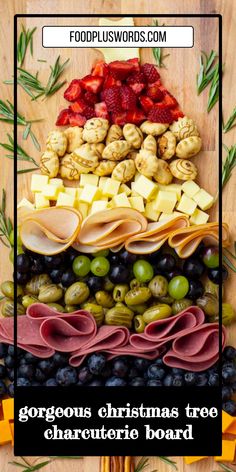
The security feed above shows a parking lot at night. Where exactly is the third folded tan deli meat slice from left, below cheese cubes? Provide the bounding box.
[125,216,189,254]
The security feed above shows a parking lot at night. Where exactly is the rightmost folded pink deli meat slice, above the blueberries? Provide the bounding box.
[163,323,226,372]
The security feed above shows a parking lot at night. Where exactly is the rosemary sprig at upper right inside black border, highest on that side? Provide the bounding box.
[197,50,218,95]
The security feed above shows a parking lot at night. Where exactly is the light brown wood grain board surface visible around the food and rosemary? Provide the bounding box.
[0,0,236,472]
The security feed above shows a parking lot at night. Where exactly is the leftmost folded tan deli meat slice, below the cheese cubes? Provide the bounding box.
[20,207,81,255]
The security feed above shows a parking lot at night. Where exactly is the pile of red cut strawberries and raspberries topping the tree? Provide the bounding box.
[56,58,184,126]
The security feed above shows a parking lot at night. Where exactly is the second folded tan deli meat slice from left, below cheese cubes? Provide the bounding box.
[78,208,147,249]
